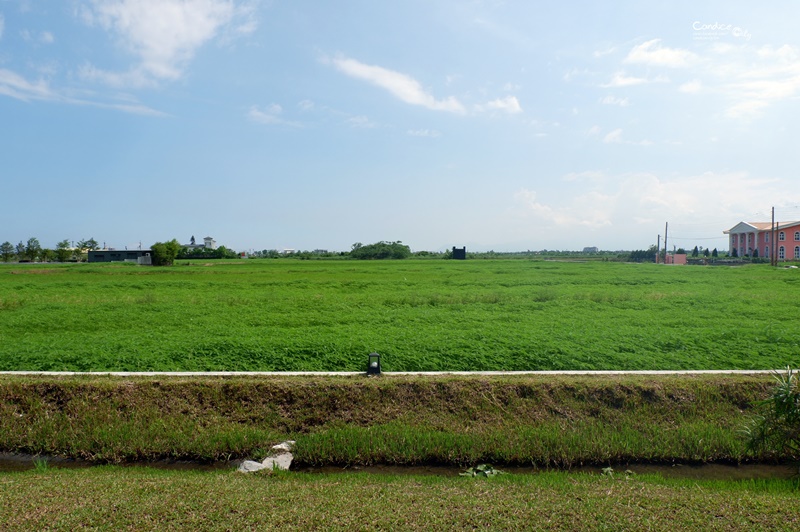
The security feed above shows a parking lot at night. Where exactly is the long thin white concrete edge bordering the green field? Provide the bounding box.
[0,368,785,377]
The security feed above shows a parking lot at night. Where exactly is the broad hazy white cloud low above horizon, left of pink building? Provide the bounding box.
[510,171,784,249]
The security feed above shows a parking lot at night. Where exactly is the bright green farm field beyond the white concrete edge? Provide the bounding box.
[0,259,800,371]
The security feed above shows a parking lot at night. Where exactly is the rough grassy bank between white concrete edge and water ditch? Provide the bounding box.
[0,375,787,466]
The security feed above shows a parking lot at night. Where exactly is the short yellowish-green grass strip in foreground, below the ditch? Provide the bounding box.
[0,467,800,531]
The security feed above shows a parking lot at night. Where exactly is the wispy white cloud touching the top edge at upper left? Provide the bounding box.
[81,0,245,87]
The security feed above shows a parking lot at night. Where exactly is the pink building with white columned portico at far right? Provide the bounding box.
[723,222,800,260]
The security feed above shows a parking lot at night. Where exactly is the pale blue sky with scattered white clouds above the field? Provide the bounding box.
[0,0,800,251]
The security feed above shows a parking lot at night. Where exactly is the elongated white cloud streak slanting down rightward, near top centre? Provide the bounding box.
[330,57,465,114]
